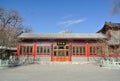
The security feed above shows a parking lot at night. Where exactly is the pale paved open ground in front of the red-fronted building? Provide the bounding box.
[0,64,120,81]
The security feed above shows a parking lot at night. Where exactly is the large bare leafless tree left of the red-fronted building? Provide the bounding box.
[0,8,31,54]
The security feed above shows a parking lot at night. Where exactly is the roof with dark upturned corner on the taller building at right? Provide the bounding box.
[98,22,120,45]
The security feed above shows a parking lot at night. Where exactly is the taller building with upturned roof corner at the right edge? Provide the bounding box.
[98,22,120,57]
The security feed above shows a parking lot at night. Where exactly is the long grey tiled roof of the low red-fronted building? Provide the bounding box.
[18,33,107,39]
